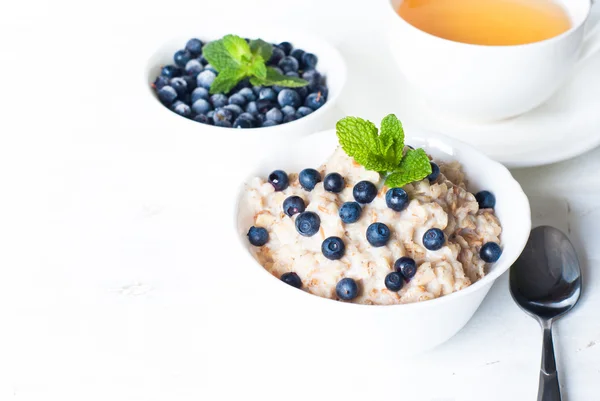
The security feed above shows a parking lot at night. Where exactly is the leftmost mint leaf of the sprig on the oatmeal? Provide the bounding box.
[335,117,396,172]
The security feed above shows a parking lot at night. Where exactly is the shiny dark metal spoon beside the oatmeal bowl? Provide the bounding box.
[510,226,581,401]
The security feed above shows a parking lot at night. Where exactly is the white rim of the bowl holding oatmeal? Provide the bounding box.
[233,129,531,310]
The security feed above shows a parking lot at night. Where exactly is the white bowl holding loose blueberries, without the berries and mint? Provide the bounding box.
[143,27,346,161]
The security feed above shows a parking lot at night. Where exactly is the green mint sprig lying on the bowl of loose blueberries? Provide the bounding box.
[202,35,308,94]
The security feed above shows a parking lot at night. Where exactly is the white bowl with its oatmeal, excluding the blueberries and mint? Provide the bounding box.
[236,125,531,355]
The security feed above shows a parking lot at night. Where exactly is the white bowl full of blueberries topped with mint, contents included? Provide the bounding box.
[145,29,346,141]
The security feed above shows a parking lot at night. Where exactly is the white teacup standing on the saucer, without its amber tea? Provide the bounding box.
[386,0,600,121]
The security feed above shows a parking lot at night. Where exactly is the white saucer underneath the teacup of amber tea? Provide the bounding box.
[340,18,600,167]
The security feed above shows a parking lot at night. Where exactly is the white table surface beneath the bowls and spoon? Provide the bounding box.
[0,0,600,401]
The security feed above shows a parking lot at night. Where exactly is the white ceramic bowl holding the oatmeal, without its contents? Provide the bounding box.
[233,127,531,356]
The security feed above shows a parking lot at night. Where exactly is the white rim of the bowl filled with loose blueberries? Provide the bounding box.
[142,28,348,134]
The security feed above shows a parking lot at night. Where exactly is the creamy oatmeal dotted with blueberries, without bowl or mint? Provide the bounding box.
[243,148,501,305]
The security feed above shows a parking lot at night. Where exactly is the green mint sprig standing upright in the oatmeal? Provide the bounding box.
[336,114,431,187]
